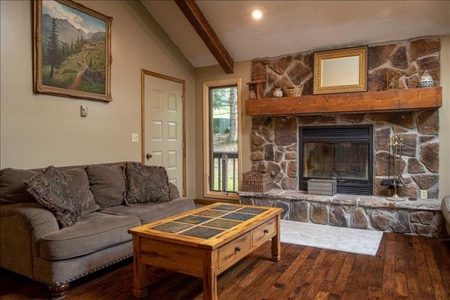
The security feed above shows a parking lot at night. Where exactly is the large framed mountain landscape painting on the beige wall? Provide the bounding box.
[33,0,112,101]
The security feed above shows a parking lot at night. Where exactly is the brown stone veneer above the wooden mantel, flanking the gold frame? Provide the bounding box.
[251,38,441,97]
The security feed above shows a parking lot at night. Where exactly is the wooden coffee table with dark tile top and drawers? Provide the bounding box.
[129,203,282,299]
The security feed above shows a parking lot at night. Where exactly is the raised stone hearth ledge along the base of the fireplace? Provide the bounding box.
[240,189,447,237]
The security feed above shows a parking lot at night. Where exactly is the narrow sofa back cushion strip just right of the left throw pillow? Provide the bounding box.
[60,168,100,215]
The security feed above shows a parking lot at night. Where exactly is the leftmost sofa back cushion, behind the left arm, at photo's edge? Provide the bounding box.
[0,168,37,204]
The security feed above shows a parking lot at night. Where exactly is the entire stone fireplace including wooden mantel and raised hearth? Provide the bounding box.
[240,38,446,237]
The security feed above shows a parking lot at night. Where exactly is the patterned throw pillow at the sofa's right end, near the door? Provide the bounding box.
[125,162,171,205]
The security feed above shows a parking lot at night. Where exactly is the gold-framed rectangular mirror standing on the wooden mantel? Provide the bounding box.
[313,46,368,95]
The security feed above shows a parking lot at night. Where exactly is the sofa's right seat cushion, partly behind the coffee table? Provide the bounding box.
[102,198,195,224]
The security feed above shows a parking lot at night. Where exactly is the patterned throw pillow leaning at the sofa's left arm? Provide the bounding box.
[25,166,82,228]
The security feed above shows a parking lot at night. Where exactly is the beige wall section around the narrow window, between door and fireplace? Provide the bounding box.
[195,61,252,198]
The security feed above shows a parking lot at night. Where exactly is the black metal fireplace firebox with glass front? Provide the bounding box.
[298,125,374,195]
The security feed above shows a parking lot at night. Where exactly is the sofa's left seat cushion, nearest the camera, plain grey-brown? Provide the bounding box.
[40,211,141,260]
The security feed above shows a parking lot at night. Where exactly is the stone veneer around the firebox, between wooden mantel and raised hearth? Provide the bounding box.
[250,111,439,198]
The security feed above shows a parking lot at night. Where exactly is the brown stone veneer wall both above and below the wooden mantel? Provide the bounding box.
[250,38,441,198]
